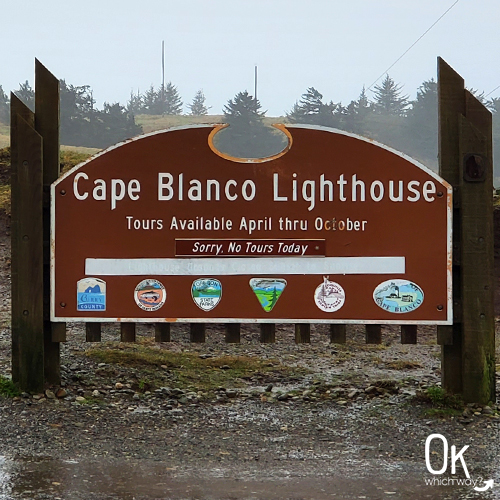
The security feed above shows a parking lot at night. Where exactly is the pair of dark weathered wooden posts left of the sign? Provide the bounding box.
[11,60,66,392]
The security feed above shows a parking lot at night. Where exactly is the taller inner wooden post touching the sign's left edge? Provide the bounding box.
[35,59,66,384]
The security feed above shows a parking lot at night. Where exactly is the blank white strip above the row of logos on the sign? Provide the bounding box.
[85,257,405,276]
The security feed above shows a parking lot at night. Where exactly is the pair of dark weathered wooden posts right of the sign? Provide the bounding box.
[438,58,495,404]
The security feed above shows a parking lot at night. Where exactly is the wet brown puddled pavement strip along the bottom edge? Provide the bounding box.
[0,458,500,500]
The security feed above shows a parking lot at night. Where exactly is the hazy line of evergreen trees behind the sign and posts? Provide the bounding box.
[0,75,500,178]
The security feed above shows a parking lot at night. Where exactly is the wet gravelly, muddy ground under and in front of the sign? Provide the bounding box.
[0,212,500,500]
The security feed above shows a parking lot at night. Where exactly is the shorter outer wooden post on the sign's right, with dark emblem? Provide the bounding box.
[459,90,496,404]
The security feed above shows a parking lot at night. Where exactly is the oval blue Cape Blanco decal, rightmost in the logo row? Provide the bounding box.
[373,280,424,314]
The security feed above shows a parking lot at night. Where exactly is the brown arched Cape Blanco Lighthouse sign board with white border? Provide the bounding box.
[51,126,452,324]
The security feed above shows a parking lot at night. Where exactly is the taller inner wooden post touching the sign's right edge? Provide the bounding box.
[438,58,465,394]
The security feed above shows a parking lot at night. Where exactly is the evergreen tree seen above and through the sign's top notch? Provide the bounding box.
[214,90,287,158]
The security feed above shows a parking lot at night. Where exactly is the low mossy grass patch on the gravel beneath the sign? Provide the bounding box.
[85,344,306,392]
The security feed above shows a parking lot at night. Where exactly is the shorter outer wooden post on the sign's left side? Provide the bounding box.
[11,113,44,392]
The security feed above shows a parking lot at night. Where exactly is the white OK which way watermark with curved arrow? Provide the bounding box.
[425,434,494,491]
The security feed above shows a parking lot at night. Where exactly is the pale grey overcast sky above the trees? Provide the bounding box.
[0,0,500,115]
